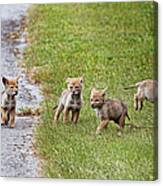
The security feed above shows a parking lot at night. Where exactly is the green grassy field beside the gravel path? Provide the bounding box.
[25,2,157,180]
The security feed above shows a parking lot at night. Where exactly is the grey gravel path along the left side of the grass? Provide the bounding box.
[0,4,43,177]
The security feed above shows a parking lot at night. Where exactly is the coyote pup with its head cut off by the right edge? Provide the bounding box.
[125,79,158,111]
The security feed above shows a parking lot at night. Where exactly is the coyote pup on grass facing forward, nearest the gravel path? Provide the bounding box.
[54,77,83,124]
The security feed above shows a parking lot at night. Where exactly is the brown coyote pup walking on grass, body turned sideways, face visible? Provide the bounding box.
[90,88,130,134]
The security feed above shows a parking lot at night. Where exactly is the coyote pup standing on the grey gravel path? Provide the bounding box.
[1,77,19,128]
